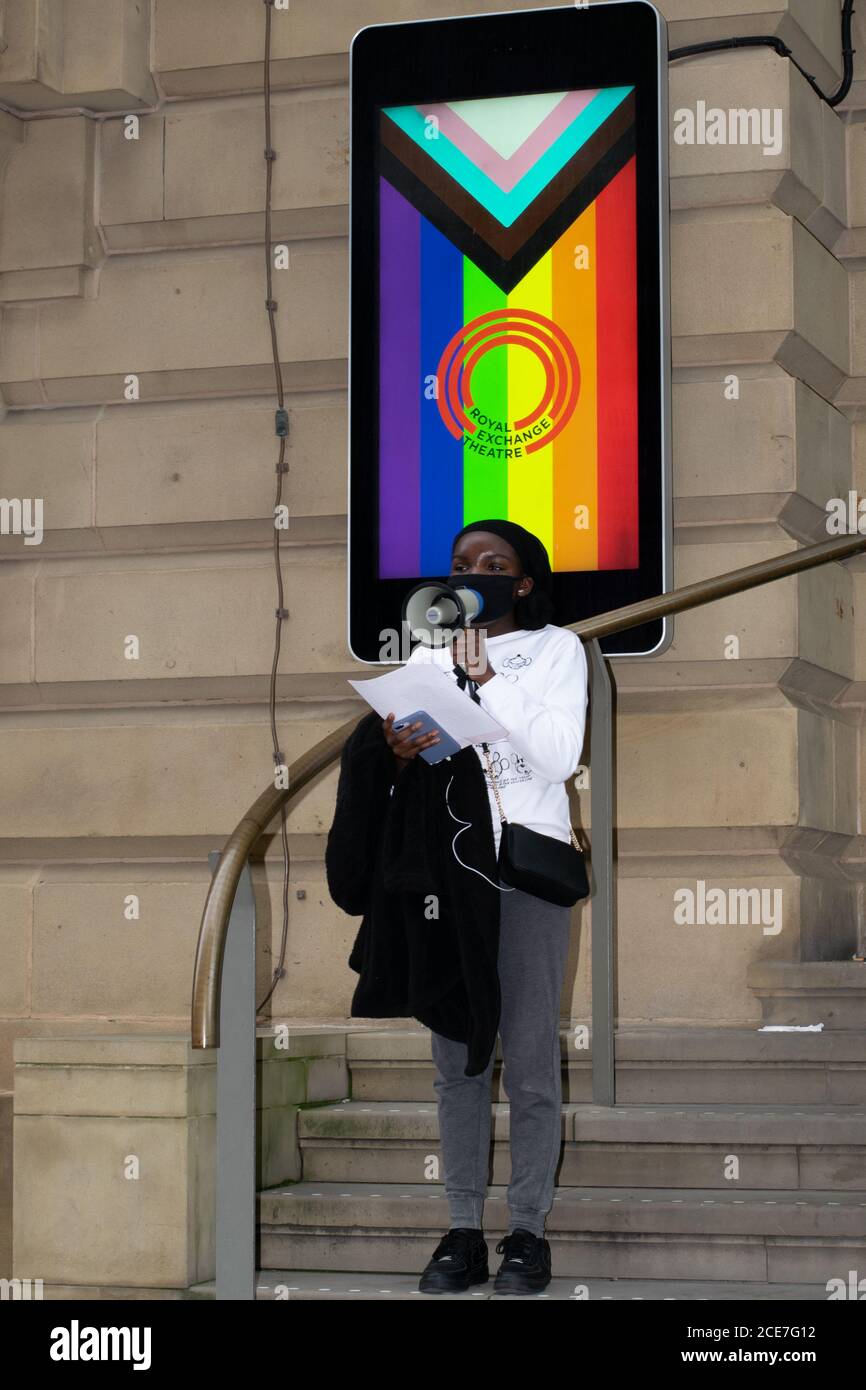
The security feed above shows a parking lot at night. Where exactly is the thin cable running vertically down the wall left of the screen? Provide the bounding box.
[256,0,289,1015]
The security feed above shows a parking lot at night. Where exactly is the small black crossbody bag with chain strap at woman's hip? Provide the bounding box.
[481,744,589,908]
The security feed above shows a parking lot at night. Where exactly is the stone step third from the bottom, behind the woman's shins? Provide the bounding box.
[297,1101,866,1191]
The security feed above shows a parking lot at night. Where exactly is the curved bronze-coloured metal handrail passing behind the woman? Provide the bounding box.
[192,535,866,1048]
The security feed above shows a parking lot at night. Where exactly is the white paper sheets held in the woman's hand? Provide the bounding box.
[349,664,509,748]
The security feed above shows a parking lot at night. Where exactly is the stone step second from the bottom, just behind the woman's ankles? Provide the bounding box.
[259,1182,866,1284]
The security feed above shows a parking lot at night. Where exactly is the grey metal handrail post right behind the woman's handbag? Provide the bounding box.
[587,638,616,1105]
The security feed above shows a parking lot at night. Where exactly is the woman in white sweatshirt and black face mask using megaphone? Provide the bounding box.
[382,518,587,1293]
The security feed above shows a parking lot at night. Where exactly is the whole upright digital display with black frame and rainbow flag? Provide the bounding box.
[348,0,673,663]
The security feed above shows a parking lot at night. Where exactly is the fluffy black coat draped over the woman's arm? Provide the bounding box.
[325,710,500,1076]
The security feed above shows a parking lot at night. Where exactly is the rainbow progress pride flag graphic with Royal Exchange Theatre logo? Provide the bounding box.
[379,86,638,578]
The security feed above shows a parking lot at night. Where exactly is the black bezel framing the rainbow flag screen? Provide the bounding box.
[348,0,670,663]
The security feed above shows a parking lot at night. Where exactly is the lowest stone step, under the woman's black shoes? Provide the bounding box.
[241,1273,827,1302]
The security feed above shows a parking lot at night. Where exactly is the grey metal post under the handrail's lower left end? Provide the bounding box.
[209,851,256,1302]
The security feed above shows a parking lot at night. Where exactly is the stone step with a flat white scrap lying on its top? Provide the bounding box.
[346,1023,866,1105]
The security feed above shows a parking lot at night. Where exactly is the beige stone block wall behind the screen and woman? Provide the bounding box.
[0,0,866,1088]
